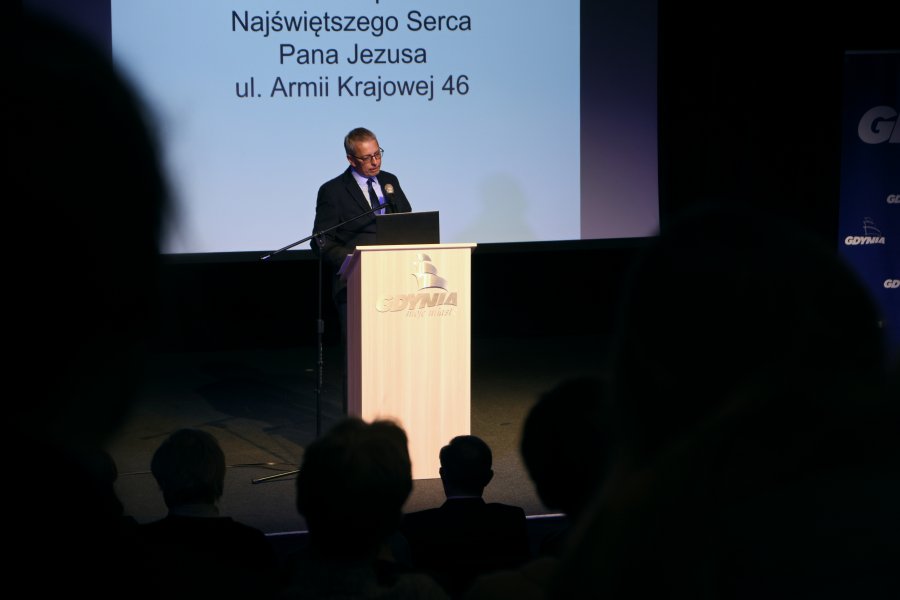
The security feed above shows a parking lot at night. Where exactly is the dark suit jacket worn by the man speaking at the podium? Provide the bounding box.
[309,167,412,298]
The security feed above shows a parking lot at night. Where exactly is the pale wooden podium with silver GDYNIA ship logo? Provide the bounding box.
[341,243,476,479]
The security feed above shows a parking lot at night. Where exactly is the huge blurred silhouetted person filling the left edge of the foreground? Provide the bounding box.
[14,9,168,598]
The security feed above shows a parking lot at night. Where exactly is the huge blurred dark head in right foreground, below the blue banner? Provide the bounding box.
[613,206,885,466]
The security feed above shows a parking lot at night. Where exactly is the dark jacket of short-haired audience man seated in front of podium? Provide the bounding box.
[400,498,531,596]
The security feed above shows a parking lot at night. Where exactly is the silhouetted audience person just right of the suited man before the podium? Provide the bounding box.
[464,376,614,600]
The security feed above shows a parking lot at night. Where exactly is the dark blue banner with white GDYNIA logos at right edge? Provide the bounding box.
[838,51,900,360]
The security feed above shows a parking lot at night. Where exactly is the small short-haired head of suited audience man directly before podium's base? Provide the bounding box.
[440,435,494,496]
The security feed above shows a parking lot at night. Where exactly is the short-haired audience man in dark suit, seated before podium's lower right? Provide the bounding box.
[400,435,531,596]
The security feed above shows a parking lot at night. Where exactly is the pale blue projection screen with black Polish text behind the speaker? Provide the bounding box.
[111,0,581,253]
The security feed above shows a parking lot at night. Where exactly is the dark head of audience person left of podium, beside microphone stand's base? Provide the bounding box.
[150,429,225,508]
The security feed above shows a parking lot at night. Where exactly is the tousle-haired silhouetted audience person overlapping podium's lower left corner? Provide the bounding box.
[281,417,448,600]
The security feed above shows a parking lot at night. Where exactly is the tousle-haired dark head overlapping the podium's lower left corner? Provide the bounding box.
[297,417,412,559]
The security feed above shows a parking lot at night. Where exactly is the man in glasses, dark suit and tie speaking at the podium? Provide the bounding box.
[310,127,412,414]
